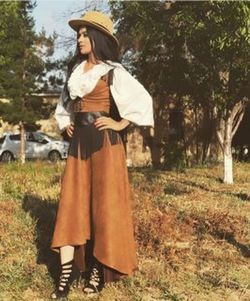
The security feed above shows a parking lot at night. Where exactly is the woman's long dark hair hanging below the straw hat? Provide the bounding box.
[67,26,120,78]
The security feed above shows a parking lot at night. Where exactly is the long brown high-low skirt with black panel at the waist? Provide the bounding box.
[51,112,137,282]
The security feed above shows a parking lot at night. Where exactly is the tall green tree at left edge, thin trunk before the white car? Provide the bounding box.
[0,1,55,163]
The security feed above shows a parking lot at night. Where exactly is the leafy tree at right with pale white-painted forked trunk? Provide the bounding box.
[176,1,250,183]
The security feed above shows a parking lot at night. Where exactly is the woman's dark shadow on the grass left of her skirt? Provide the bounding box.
[22,194,60,282]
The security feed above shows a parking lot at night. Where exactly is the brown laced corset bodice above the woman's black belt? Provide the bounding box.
[73,76,110,113]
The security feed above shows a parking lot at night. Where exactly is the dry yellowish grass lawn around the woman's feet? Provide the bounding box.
[0,161,250,301]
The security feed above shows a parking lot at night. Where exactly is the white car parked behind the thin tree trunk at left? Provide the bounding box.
[0,132,69,162]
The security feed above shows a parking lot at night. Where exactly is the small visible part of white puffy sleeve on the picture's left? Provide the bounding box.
[54,95,74,132]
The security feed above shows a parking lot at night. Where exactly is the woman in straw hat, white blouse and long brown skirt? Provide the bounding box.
[51,11,154,298]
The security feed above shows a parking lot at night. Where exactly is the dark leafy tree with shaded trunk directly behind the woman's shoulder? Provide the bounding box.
[110,1,185,167]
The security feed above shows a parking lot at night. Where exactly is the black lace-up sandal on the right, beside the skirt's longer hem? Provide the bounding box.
[83,262,104,295]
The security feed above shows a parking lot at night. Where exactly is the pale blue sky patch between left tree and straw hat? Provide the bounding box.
[32,0,107,58]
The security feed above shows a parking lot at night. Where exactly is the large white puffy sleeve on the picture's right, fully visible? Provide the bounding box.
[110,65,154,126]
